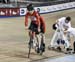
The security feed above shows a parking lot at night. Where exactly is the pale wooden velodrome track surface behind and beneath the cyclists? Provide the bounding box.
[0,9,75,62]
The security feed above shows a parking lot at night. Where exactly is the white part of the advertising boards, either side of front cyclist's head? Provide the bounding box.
[20,2,75,16]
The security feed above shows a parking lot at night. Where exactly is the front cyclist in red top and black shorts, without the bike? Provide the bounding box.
[25,4,40,46]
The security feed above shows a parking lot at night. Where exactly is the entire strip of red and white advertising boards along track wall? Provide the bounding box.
[0,2,75,16]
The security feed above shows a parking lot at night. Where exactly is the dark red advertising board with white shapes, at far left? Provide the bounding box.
[0,8,20,16]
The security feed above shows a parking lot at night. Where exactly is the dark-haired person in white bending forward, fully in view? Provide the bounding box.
[50,16,71,51]
